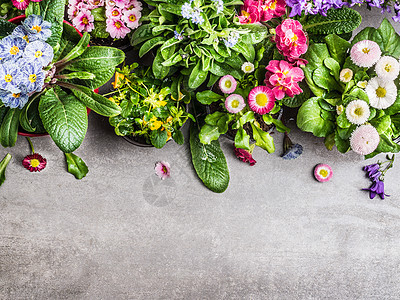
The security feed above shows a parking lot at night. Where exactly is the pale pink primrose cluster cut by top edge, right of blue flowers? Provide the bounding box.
[68,0,142,39]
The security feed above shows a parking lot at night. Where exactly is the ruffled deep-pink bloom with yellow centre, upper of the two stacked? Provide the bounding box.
[275,19,308,61]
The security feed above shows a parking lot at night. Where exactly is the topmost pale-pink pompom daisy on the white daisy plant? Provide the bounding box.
[350,40,382,68]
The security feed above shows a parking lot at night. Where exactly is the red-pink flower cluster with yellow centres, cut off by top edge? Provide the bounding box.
[239,0,286,24]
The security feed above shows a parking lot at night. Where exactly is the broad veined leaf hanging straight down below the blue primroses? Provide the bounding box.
[39,87,88,153]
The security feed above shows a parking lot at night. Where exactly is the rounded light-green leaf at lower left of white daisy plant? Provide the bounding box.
[297,97,335,137]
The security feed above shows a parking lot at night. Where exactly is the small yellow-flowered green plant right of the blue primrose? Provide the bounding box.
[110,63,192,148]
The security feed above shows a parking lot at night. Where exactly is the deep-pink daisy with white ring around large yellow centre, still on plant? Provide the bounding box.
[249,85,276,115]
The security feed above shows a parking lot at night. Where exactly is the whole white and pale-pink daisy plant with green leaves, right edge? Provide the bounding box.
[297,19,400,158]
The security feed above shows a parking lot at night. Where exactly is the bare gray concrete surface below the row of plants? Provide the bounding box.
[0,6,400,299]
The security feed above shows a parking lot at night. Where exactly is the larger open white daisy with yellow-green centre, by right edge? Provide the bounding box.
[365,77,397,109]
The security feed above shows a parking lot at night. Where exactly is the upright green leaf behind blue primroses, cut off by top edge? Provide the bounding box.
[25,0,65,49]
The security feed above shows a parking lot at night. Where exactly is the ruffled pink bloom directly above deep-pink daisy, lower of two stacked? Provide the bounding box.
[264,60,304,100]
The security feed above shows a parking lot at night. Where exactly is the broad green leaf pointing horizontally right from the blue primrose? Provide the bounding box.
[66,46,125,73]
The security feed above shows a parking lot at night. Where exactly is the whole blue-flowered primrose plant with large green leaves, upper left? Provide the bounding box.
[0,0,125,153]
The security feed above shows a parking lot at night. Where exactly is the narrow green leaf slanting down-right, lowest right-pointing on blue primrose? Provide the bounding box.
[65,85,121,117]
